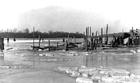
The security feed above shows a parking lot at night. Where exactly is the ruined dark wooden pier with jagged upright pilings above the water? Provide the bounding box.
[32,24,140,51]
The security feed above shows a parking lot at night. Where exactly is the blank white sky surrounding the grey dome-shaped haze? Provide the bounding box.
[0,0,140,30]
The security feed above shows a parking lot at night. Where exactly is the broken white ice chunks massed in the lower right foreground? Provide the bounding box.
[58,67,140,83]
